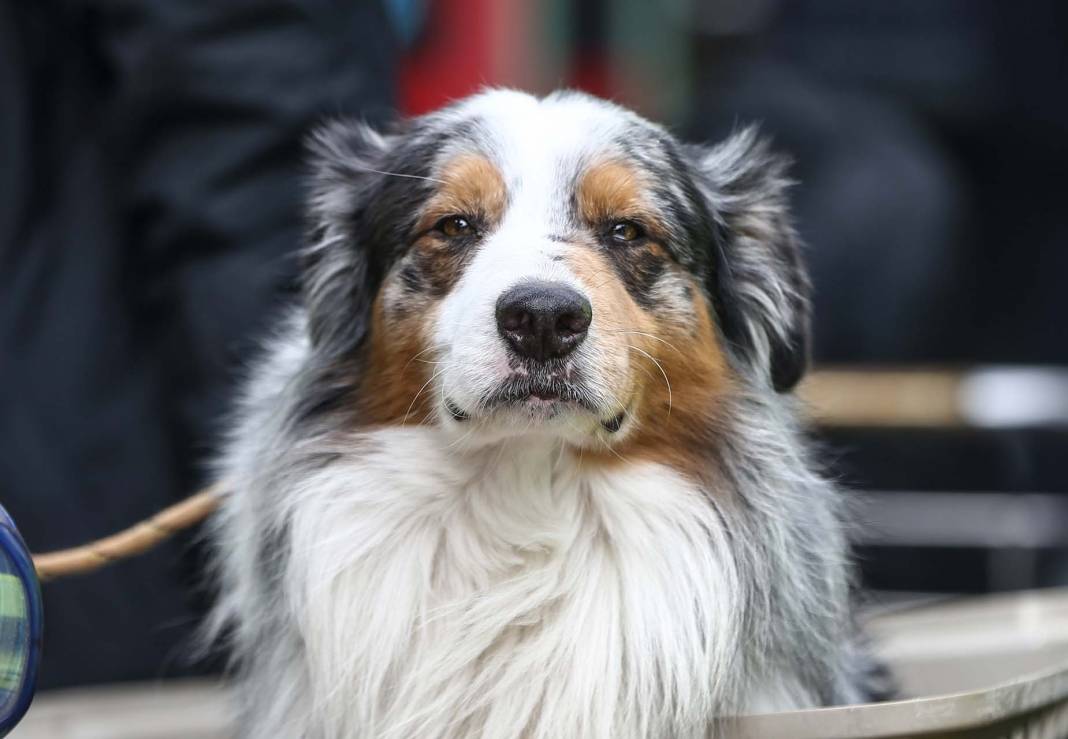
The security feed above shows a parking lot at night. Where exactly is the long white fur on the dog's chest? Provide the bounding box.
[286,429,760,738]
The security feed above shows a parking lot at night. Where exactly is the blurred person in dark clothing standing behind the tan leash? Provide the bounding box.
[0,0,395,688]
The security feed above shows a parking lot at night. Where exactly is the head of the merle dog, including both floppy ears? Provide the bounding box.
[304,91,808,449]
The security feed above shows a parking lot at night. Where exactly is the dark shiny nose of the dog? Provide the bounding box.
[497,282,594,362]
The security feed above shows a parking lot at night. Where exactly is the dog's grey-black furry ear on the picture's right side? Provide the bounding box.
[692,128,811,392]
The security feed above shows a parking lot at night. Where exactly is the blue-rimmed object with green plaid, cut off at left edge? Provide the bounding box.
[0,506,43,737]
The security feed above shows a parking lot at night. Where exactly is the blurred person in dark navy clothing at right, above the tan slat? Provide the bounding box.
[688,0,1068,365]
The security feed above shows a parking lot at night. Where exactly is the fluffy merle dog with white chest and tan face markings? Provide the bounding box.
[211,90,869,739]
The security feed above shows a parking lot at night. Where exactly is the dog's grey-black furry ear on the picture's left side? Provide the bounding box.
[301,121,394,357]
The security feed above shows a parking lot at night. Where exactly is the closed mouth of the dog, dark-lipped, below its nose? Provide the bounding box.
[444,375,627,434]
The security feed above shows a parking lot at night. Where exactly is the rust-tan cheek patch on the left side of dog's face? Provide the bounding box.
[355,293,435,426]
